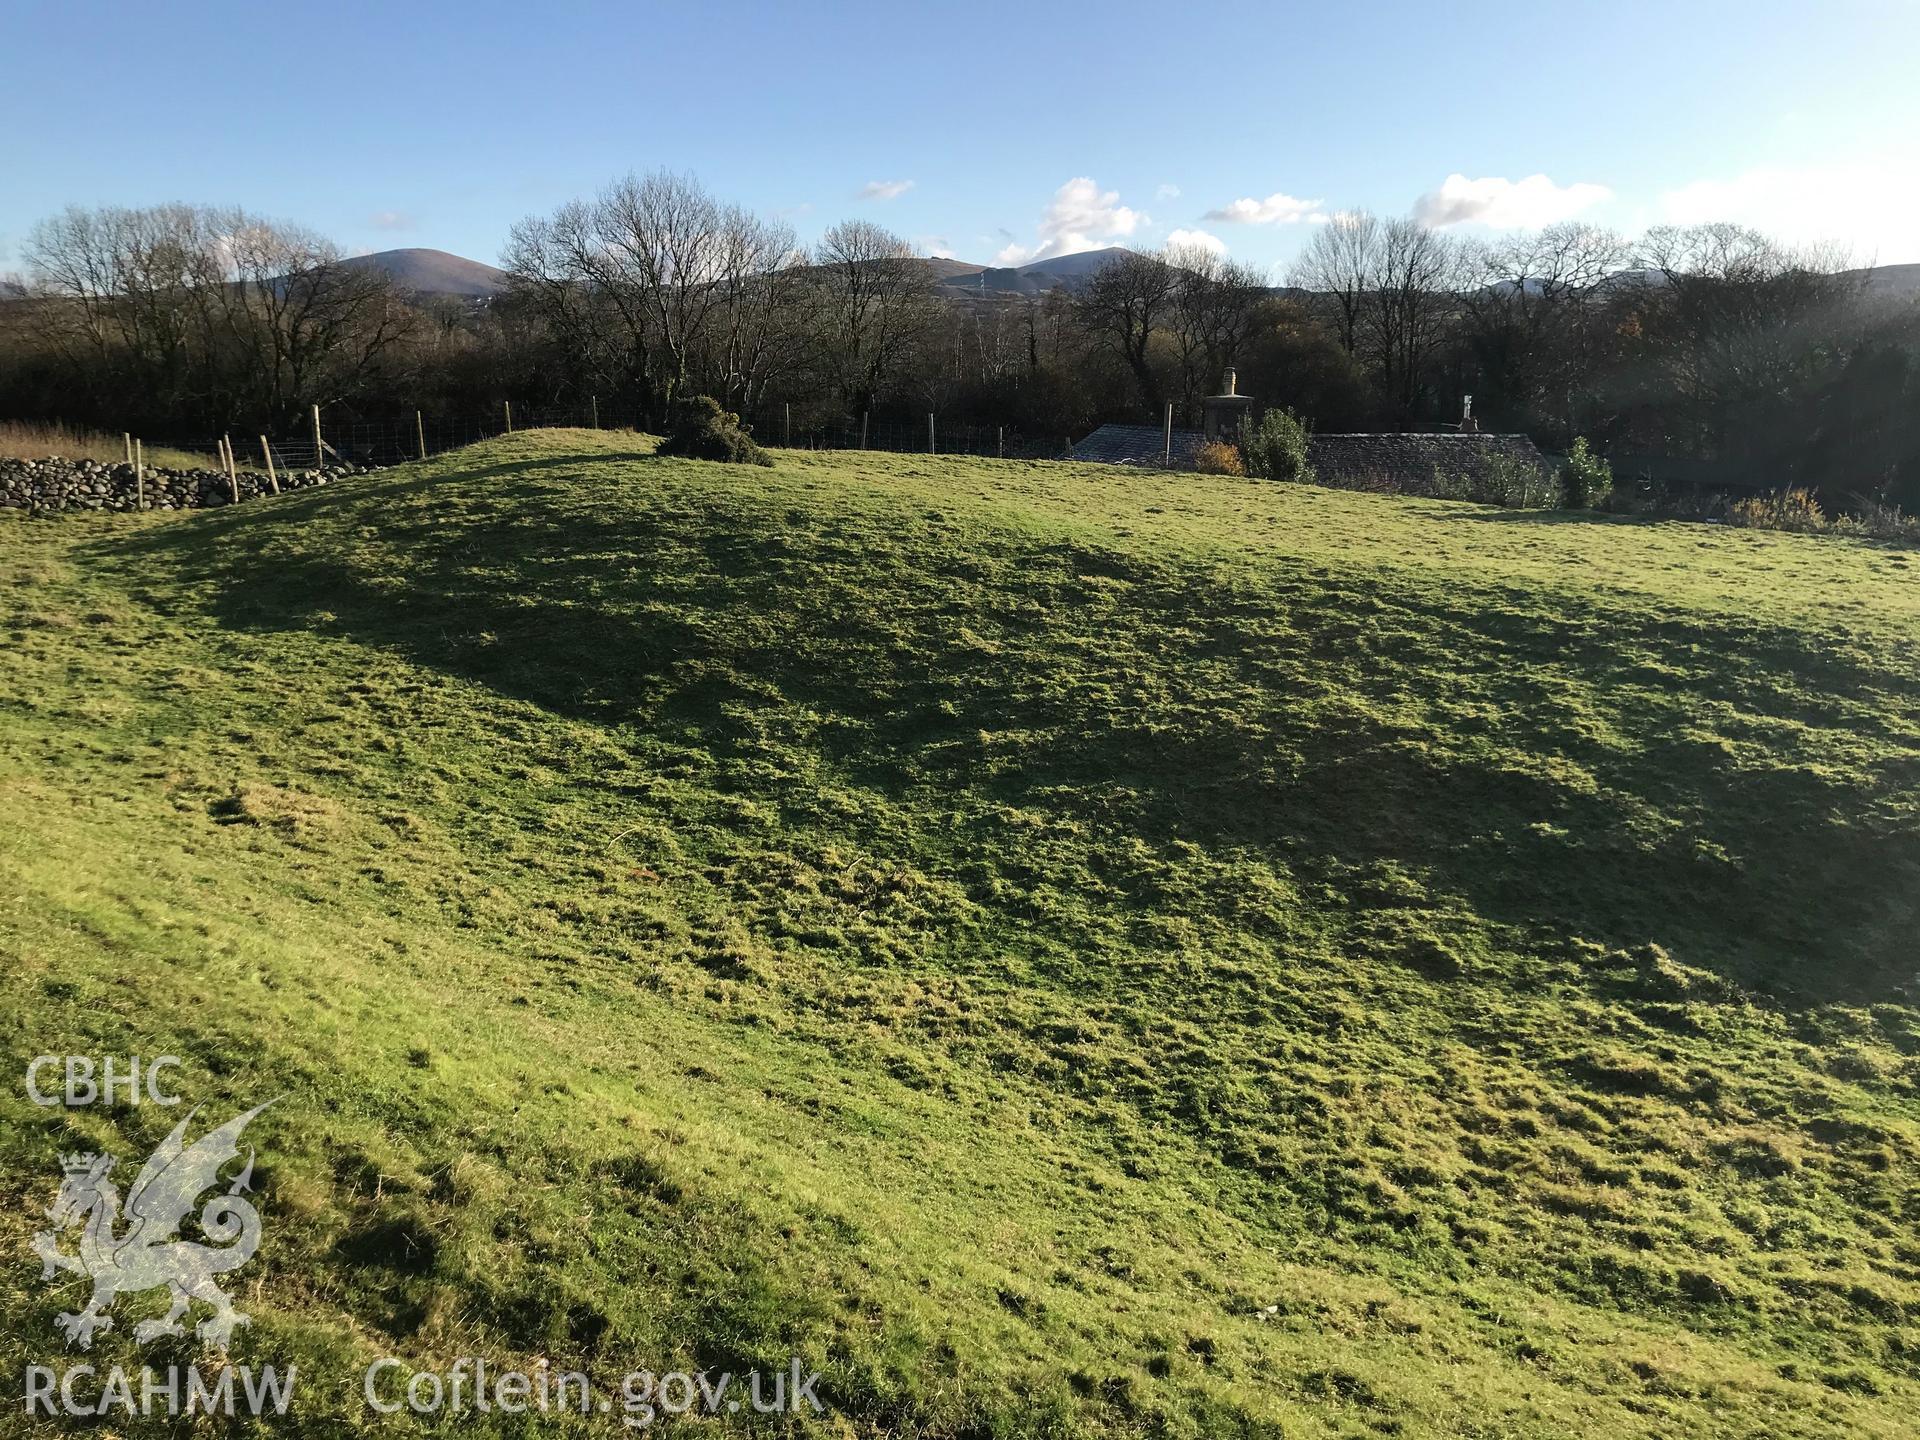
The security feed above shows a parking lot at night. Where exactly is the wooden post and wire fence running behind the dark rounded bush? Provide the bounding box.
[140,399,1071,470]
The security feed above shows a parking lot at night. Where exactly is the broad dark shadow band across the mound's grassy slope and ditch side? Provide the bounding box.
[100,455,1920,1000]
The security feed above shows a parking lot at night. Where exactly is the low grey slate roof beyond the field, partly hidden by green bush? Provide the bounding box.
[1073,424,1546,490]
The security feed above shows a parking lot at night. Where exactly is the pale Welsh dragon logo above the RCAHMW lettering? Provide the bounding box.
[33,1100,273,1350]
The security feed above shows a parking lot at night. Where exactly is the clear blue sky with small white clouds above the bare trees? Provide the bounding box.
[0,0,1920,271]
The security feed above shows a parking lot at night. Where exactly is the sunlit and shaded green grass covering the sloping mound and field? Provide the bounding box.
[0,432,1920,1436]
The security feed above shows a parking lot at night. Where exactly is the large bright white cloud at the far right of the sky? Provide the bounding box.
[1657,154,1920,265]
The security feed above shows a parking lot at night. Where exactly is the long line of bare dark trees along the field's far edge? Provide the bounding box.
[0,173,1920,505]
